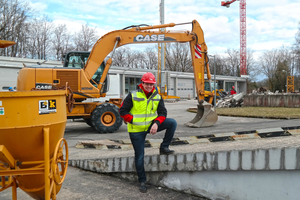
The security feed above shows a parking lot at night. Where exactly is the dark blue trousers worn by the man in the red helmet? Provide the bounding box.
[129,118,177,183]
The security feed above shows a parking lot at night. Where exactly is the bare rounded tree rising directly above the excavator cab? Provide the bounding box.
[74,24,99,51]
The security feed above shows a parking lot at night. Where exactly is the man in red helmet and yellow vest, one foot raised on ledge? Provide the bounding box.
[120,72,177,193]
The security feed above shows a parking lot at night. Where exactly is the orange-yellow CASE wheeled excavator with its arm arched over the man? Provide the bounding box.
[17,20,218,133]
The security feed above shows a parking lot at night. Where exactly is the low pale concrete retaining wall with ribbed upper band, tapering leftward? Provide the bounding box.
[69,147,300,200]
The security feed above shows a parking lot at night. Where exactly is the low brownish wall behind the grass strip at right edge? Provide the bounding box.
[244,93,300,108]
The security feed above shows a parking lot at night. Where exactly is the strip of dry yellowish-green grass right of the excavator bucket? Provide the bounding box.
[216,107,300,119]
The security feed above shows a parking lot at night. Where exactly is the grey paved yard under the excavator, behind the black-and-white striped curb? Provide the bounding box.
[65,100,300,146]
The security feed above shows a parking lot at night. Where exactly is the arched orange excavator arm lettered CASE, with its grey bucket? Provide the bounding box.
[84,20,217,127]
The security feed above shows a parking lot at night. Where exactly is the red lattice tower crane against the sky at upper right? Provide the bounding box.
[221,0,247,76]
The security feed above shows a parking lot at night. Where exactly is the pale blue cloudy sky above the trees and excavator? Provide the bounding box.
[25,0,300,55]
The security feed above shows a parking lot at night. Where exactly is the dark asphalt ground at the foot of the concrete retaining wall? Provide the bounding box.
[0,167,205,200]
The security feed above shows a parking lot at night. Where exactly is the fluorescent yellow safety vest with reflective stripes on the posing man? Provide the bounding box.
[127,90,161,133]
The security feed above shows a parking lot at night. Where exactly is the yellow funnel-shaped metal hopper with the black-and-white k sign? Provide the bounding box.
[0,90,67,199]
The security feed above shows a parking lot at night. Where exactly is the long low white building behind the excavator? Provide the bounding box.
[0,56,247,101]
